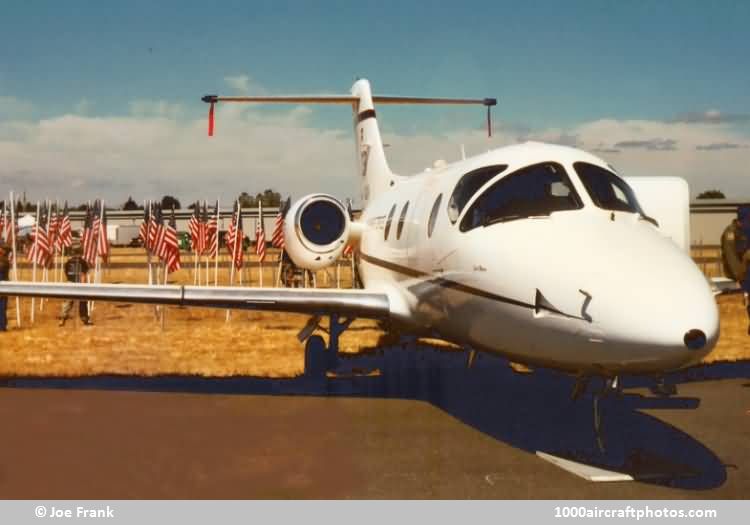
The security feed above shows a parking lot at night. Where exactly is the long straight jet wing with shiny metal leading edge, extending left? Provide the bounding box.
[0,281,390,319]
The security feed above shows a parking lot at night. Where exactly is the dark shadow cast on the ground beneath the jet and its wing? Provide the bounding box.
[5,343,750,489]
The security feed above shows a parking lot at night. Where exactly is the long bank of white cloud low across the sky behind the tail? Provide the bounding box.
[0,100,750,207]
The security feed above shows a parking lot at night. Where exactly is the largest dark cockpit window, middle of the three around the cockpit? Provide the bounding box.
[461,162,583,231]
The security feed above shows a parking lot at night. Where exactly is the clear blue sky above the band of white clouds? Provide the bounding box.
[0,1,750,202]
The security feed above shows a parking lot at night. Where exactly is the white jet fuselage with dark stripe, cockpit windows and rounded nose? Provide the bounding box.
[359,143,719,375]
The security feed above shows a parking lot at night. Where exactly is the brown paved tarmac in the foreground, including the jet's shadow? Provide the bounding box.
[0,346,750,499]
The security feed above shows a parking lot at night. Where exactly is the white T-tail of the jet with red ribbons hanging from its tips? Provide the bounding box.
[202,79,497,205]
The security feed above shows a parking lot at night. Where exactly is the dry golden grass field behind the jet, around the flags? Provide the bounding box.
[0,249,750,377]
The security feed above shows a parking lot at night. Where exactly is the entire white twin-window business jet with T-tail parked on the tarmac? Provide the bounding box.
[0,80,719,383]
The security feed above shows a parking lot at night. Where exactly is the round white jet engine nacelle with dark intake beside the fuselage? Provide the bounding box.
[284,193,351,270]
